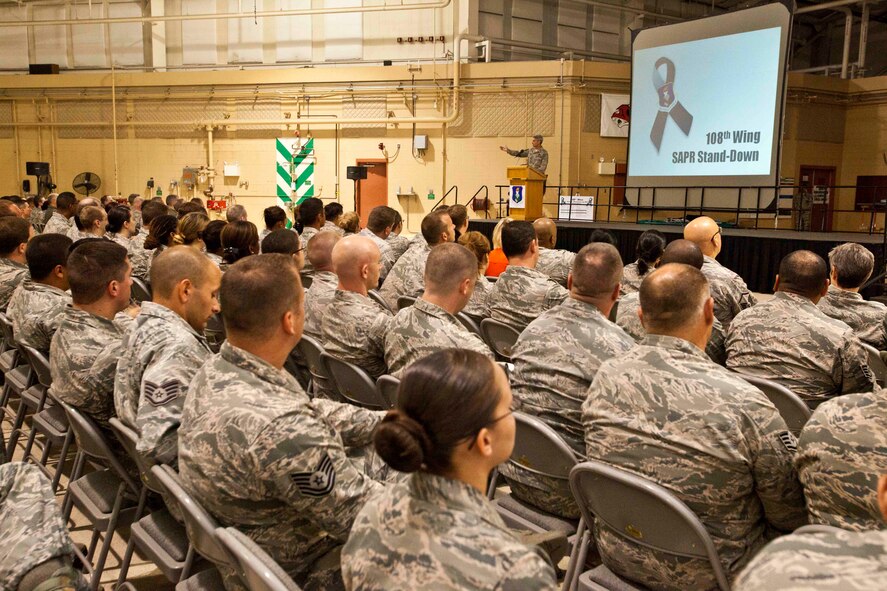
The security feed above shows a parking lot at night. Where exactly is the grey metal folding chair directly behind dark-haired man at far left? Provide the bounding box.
[59,402,144,589]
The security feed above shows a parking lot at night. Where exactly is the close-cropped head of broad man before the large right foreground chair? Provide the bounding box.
[640,263,709,335]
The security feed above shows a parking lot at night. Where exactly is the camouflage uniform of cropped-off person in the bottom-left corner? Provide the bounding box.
[0,462,88,591]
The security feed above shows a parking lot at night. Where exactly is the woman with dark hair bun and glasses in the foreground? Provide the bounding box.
[342,349,556,591]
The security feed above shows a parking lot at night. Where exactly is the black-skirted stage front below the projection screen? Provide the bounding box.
[468,219,884,298]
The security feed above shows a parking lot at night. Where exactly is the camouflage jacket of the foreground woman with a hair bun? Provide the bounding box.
[342,472,557,591]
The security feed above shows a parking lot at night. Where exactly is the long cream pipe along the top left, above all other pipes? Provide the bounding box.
[0,0,452,28]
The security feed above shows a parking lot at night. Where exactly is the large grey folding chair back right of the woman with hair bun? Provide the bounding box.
[570,461,730,591]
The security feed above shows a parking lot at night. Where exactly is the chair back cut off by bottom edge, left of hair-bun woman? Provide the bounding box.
[216,527,300,591]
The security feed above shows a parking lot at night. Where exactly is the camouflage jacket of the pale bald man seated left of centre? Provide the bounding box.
[321,289,392,379]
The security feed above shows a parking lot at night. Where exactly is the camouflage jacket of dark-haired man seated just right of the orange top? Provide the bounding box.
[488,265,570,331]
